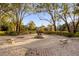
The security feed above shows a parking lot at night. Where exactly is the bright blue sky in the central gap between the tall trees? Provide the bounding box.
[23,14,50,27]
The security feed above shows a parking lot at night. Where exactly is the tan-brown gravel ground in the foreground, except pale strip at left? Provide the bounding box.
[0,35,79,56]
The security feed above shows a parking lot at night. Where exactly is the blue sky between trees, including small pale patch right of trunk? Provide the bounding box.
[23,13,64,27]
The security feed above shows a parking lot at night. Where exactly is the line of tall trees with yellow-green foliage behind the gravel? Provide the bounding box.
[0,3,79,34]
